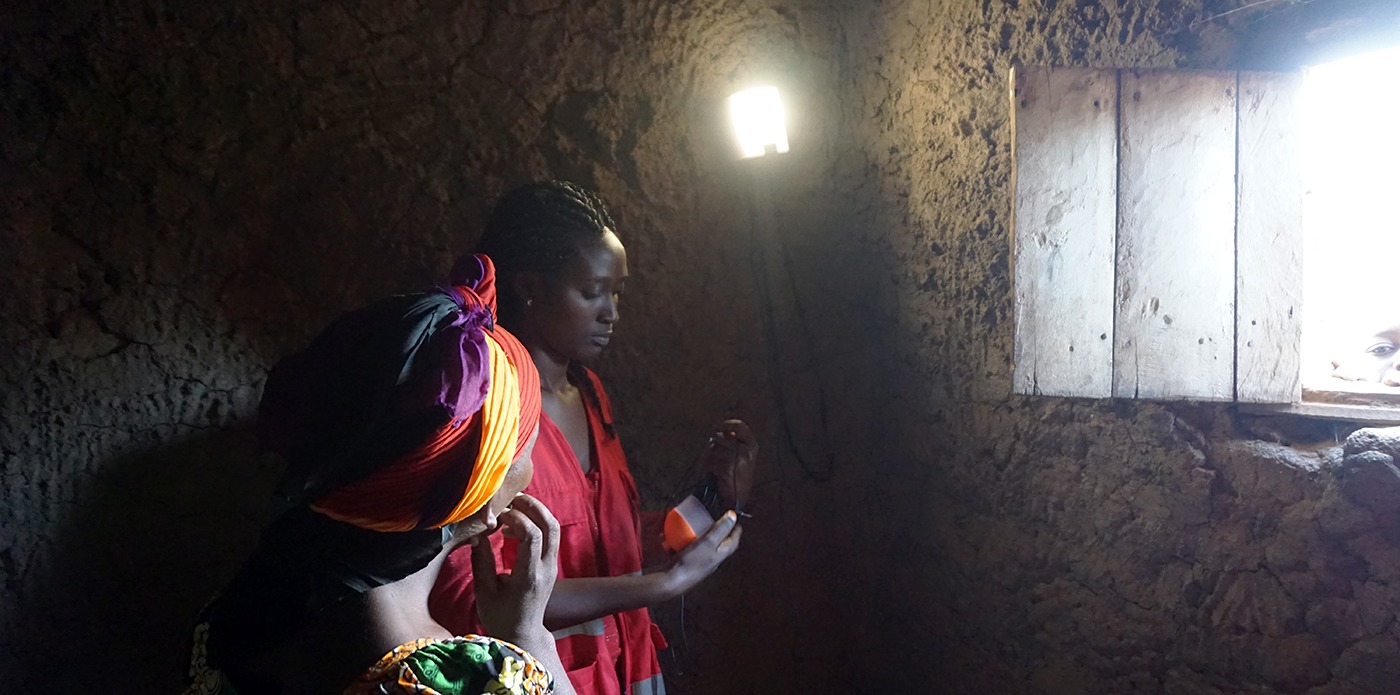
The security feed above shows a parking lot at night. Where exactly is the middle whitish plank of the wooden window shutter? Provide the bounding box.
[1113,70,1235,401]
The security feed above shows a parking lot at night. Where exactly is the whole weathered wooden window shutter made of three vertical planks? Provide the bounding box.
[1012,67,1302,402]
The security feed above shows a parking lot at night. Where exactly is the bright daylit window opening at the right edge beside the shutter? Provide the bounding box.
[1301,49,1400,402]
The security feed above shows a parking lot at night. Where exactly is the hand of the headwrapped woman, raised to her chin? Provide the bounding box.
[472,493,559,646]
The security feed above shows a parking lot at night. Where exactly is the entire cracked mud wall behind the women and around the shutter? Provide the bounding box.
[8,0,1400,694]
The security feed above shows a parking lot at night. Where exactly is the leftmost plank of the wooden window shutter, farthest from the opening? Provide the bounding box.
[1011,67,1117,398]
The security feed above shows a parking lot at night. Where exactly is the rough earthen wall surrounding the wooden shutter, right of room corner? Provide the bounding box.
[828,0,1400,694]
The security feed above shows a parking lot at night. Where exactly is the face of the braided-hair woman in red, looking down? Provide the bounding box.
[521,230,627,362]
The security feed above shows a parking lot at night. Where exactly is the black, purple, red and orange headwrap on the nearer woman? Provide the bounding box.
[259,256,540,531]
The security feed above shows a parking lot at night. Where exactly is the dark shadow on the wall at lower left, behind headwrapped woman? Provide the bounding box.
[14,425,280,692]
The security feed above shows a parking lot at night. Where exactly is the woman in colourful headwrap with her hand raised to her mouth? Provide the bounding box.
[186,256,573,695]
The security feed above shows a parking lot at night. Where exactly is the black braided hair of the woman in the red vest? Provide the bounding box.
[476,181,617,436]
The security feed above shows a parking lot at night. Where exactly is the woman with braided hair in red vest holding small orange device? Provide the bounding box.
[430,181,757,695]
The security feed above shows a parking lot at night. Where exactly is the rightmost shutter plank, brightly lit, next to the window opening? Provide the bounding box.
[1235,73,1303,404]
